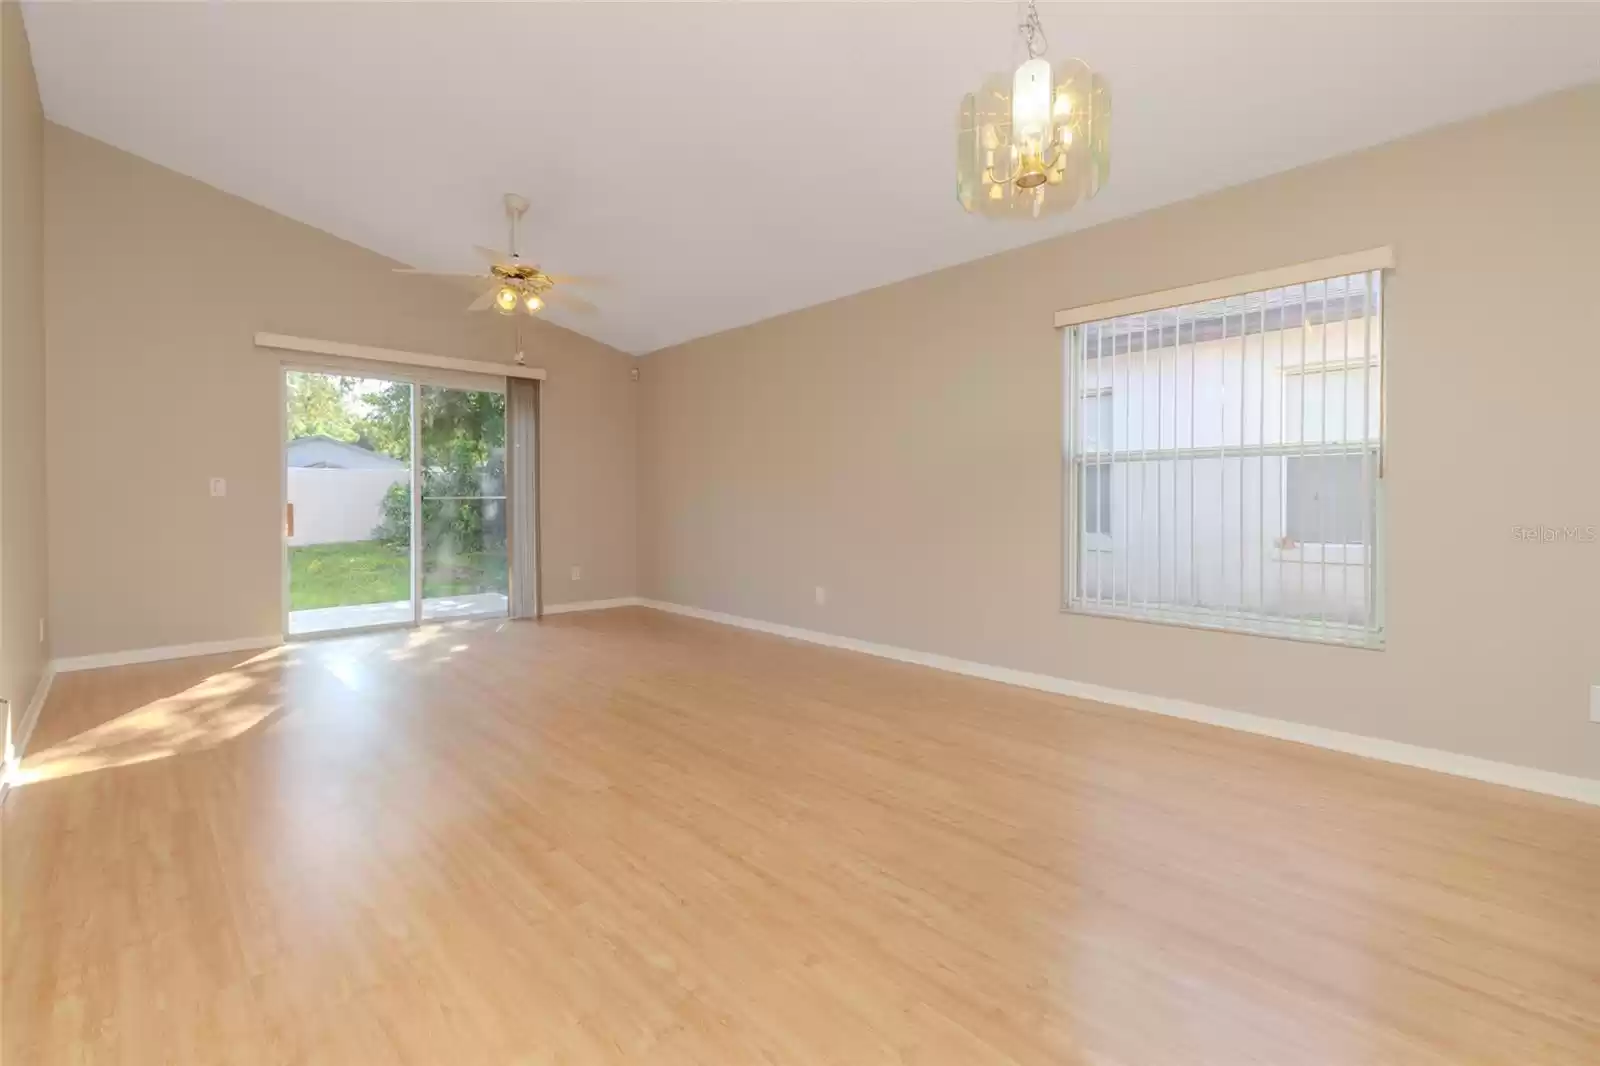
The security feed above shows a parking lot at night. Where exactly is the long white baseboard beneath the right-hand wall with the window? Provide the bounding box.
[640,600,1600,807]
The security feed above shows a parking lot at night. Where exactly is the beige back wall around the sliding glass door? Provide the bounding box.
[45,125,637,656]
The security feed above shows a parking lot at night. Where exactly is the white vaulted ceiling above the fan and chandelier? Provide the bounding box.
[26,3,1600,352]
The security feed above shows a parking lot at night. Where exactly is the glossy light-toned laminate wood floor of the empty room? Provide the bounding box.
[0,610,1600,1066]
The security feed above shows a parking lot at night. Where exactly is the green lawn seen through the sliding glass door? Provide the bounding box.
[290,541,506,611]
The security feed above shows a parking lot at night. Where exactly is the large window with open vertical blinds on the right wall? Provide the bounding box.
[1064,262,1384,645]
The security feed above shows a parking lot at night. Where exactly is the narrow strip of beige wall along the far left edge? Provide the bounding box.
[0,3,48,720]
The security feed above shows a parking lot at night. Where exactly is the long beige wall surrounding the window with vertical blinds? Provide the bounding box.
[638,86,1600,776]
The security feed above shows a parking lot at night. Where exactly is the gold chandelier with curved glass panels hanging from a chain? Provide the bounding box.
[955,0,1110,218]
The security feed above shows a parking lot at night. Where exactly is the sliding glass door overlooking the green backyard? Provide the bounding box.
[283,370,510,635]
